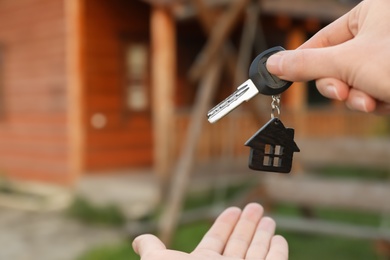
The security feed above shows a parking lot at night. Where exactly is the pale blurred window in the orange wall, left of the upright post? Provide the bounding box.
[125,43,149,111]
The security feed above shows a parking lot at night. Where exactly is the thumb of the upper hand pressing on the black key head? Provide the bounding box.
[267,46,348,81]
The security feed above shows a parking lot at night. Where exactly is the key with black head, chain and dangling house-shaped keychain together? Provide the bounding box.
[207,47,299,173]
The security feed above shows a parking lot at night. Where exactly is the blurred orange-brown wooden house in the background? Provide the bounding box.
[0,0,380,184]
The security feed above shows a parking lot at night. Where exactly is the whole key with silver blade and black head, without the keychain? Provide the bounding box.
[207,46,292,123]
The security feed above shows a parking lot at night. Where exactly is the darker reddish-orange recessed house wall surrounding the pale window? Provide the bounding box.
[84,0,153,172]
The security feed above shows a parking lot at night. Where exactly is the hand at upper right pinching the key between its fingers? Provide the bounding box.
[267,0,390,112]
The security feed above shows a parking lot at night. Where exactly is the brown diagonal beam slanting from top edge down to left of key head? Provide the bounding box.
[189,0,249,81]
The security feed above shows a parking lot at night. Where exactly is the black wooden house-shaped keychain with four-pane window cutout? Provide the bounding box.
[245,117,300,173]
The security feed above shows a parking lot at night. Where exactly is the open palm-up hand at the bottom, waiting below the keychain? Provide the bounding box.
[133,203,288,260]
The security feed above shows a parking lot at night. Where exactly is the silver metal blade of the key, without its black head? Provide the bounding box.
[207,79,259,123]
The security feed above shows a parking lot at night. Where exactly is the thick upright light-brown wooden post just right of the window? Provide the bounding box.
[150,5,176,194]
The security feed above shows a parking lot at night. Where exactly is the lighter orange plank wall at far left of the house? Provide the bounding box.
[0,0,72,183]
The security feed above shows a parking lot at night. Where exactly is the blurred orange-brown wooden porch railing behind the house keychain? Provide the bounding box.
[174,106,390,162]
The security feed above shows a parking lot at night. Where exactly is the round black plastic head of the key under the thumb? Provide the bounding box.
[249,46,292,96]
